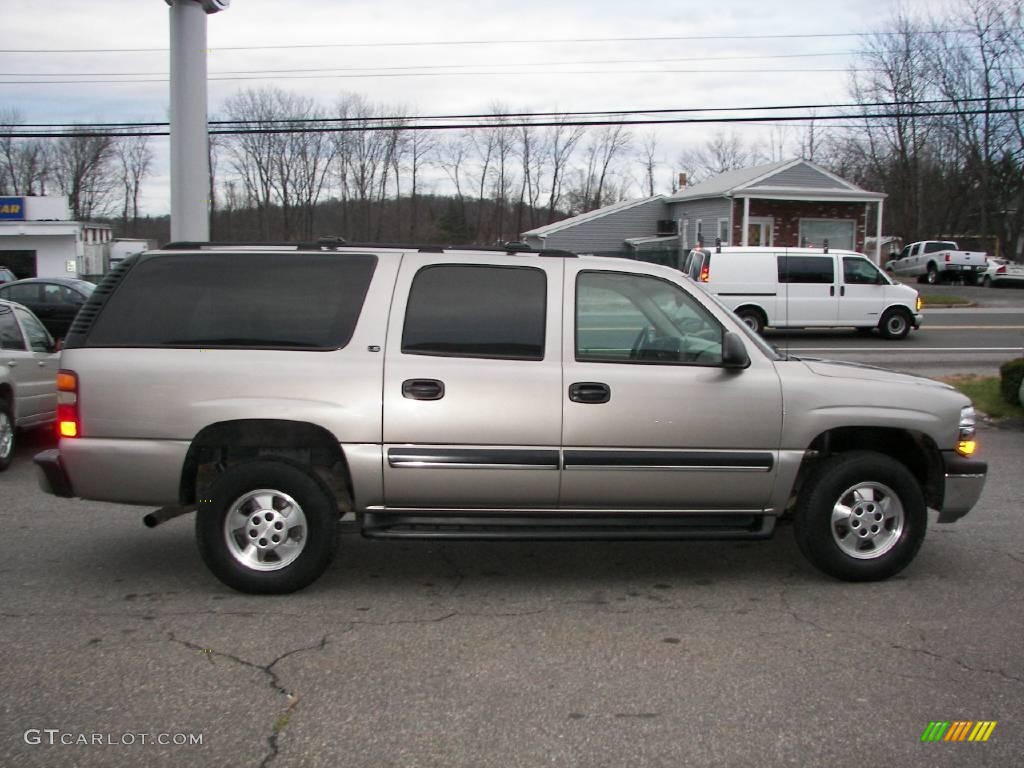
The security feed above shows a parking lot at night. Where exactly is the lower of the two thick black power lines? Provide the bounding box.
[4,108,1024,138]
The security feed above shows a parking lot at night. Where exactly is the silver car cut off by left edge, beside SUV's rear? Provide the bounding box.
[0,300,57,471]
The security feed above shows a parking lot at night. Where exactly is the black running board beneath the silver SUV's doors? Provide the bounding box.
[362,510,775,541]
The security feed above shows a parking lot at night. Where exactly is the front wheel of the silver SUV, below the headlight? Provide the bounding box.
[794,451,928,582]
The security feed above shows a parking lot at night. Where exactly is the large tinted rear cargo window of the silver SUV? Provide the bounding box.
[86,252,377,349]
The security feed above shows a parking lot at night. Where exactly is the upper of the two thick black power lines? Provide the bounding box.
[11,96,1020,131]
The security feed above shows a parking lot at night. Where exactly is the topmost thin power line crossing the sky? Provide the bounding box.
[0,29,970,53]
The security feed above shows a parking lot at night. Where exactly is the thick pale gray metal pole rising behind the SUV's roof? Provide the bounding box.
[166,0,231,241]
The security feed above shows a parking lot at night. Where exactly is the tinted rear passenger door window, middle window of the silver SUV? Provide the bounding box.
[401,264,548,360]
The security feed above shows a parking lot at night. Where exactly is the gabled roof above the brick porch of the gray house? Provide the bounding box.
[666,158,886,203]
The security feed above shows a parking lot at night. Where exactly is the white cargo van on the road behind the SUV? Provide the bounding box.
[681,247,922,339]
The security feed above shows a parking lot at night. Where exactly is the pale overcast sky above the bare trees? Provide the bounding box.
[0,0,948,213]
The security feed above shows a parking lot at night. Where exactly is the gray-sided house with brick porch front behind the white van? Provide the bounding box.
[522,159,886,263]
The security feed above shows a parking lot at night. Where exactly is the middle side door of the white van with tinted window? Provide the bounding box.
[772,253,839,328]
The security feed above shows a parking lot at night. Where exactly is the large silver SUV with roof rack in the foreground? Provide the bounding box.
[36,244,986,593]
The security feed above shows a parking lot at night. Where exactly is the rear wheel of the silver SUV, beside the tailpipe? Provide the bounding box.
[196,460,338,595]
